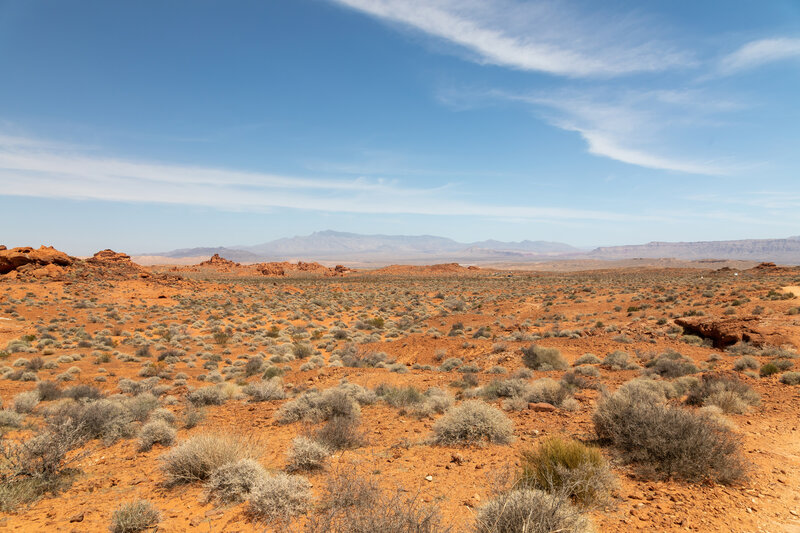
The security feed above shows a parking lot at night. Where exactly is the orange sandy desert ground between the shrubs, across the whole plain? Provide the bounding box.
[0,262,800,532]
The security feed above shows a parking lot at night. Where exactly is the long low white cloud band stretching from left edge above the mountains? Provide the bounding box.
[0,134,636,222]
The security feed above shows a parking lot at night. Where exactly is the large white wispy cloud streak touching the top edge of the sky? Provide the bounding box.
[333,0,694,77]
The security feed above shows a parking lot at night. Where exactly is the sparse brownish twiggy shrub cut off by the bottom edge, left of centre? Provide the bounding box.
[305,469,450,533]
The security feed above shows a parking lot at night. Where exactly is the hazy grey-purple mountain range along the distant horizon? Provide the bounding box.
[141,230,800,264]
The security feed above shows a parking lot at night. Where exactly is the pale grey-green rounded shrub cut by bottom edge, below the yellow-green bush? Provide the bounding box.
[475,489,593,533]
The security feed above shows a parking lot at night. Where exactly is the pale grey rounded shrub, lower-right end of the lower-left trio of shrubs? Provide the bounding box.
[247,473,311,522]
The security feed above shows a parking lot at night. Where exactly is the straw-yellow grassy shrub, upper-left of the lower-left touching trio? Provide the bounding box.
[160,434,255,484]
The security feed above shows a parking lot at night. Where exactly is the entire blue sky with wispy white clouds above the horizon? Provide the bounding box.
[0,0,800,254]
